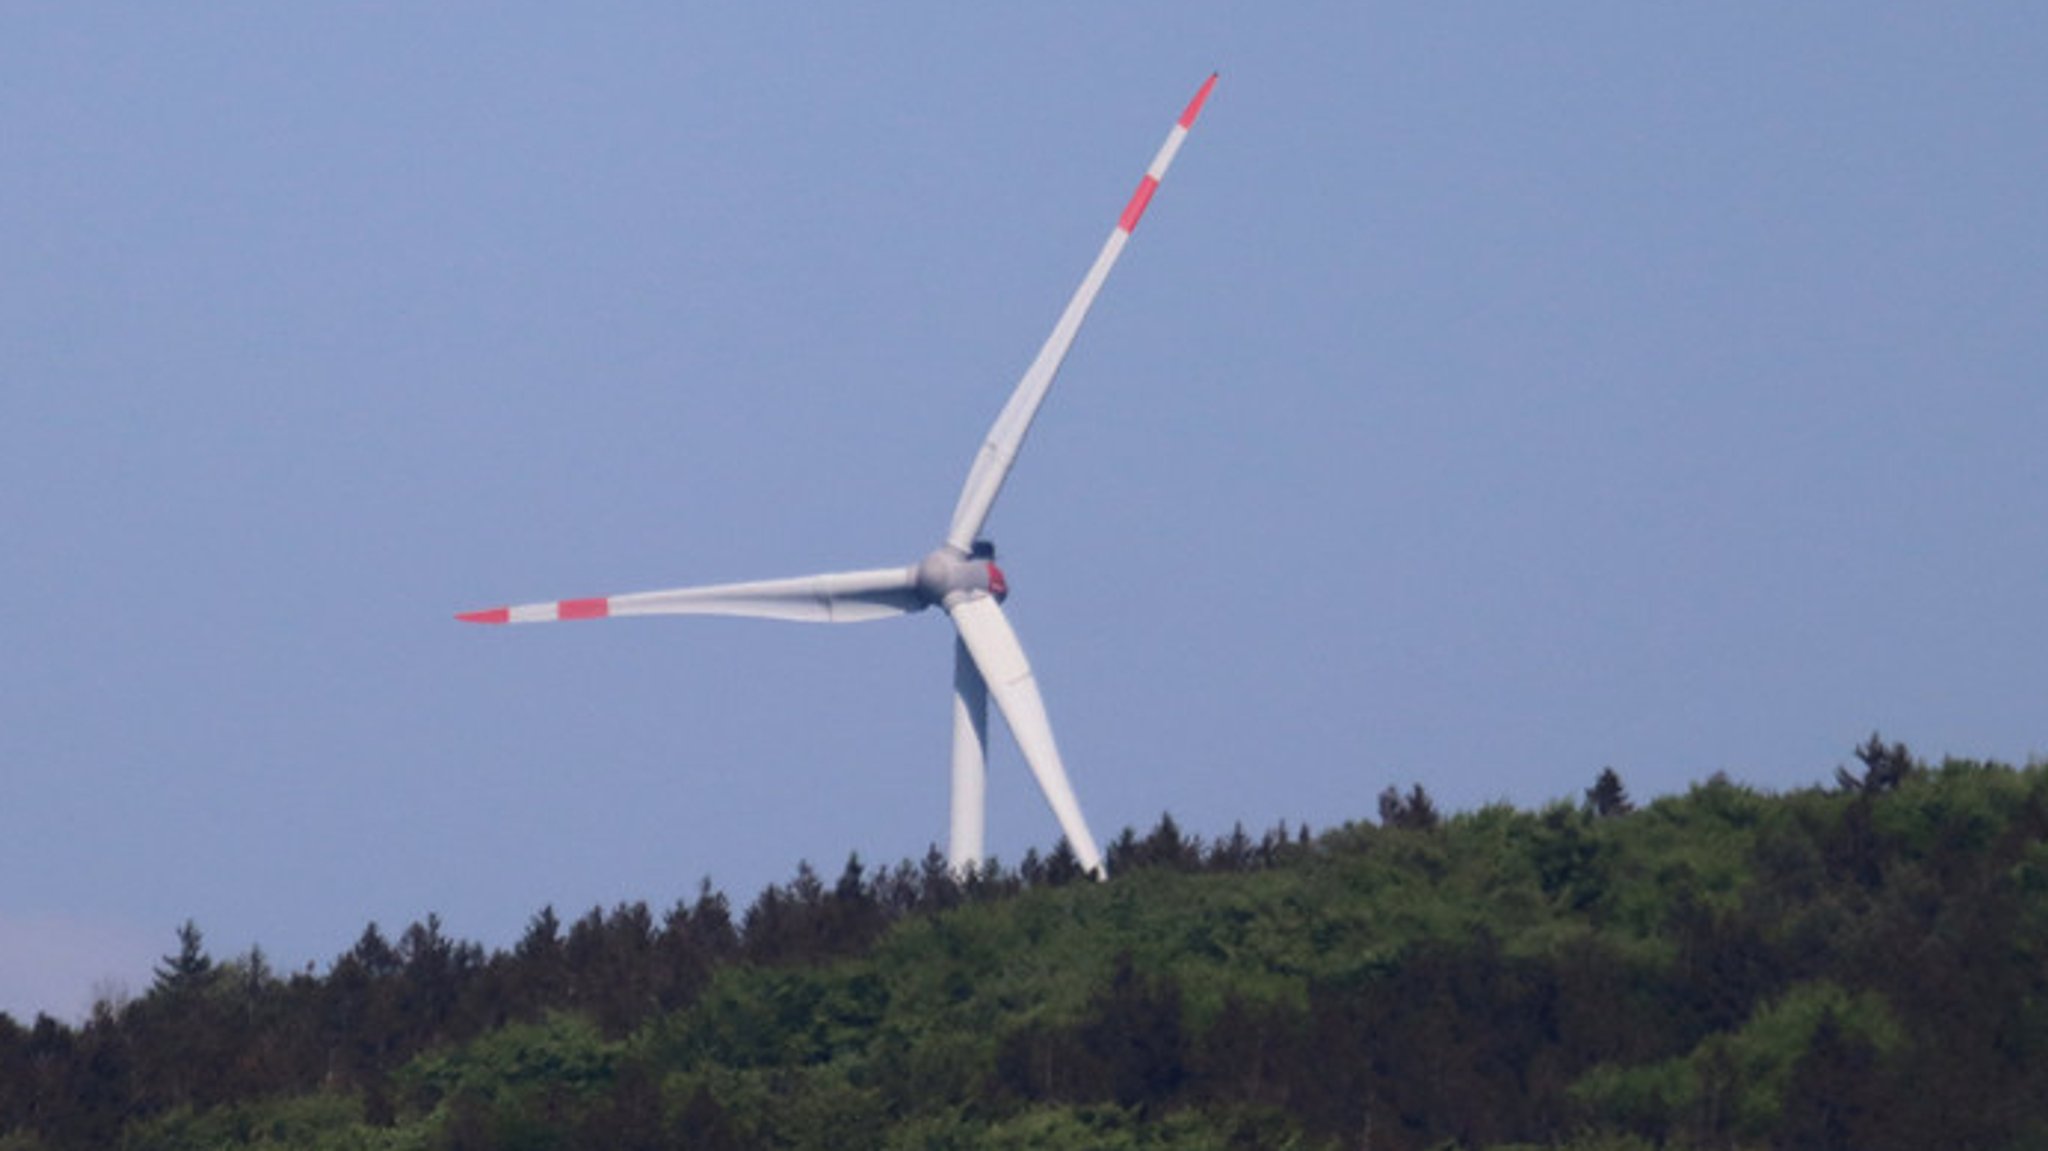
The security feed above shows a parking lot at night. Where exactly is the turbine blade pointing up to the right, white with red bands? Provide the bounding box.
[946,76,1217,555]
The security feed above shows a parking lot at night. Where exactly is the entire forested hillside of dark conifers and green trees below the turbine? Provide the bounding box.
[0,737,2048,1151]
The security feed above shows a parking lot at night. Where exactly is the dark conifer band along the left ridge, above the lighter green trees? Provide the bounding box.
[0,815,1311,1151]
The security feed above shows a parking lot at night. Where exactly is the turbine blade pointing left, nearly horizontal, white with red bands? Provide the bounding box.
[455,567,924,623]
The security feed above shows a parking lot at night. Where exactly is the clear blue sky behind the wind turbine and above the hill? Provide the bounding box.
[0,2,2048,1018]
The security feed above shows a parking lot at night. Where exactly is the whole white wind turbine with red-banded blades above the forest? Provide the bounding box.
[455,76,1217,877]
